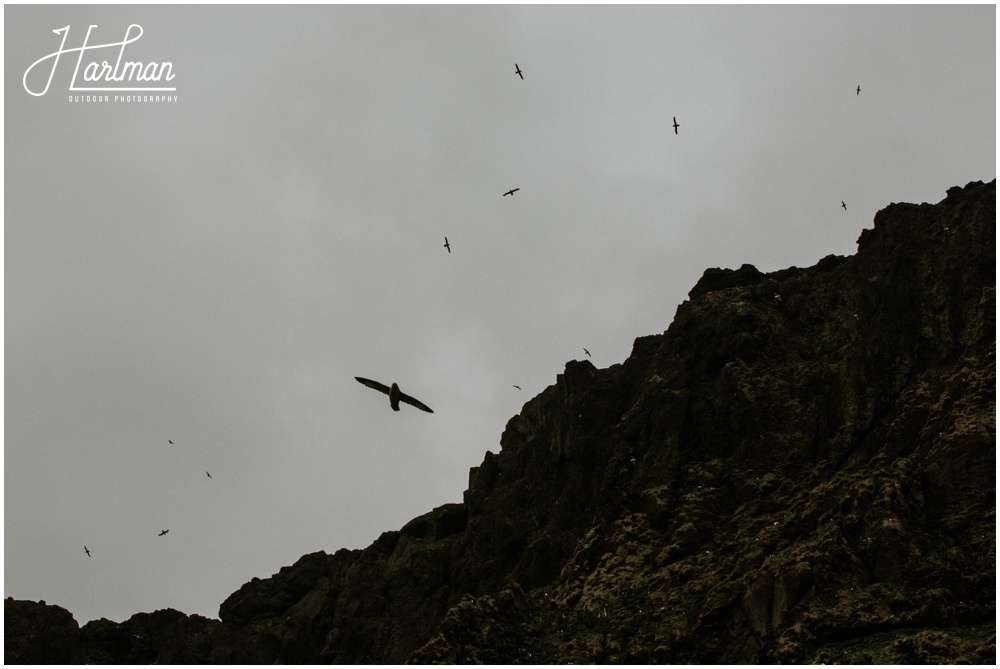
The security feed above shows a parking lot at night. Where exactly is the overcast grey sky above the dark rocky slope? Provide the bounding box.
[4,5,996,623]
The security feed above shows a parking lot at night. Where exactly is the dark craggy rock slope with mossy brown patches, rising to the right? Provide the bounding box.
[5,181,996,664]
